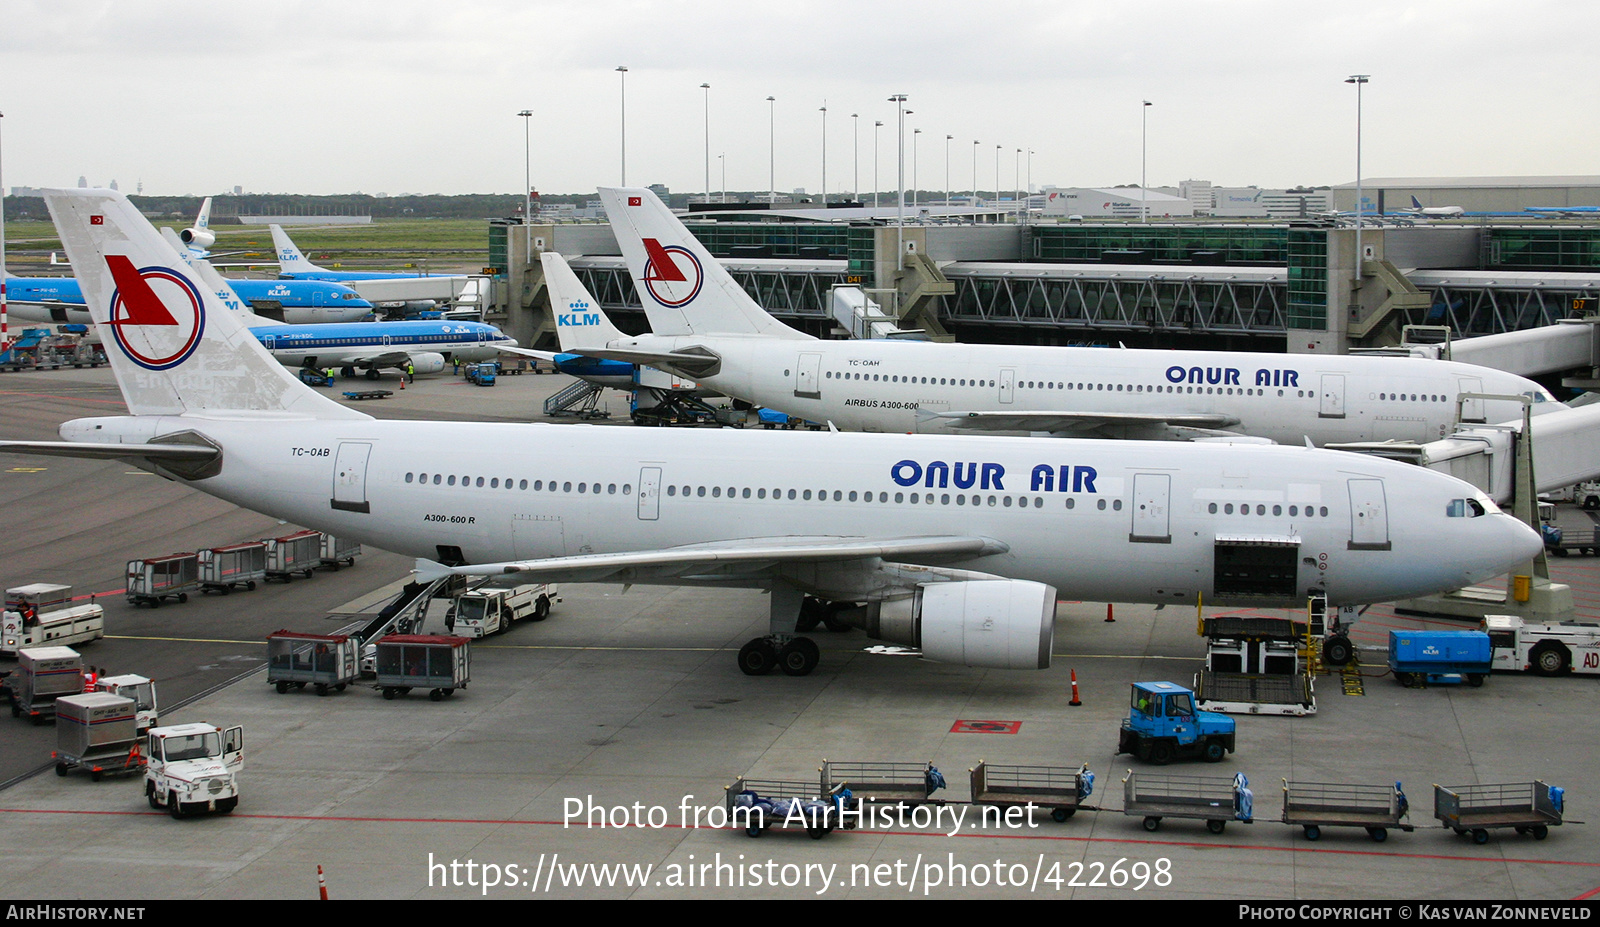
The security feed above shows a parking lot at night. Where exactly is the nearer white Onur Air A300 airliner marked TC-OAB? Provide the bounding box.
[0,191,1541,676]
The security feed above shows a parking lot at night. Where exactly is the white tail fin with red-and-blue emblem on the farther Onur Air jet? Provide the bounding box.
[600,187,813,341]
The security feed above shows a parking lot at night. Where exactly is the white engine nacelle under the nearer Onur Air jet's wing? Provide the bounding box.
[864,580,1056,669]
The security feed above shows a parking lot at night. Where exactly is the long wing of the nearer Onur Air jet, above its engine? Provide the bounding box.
[416,536,1011,583]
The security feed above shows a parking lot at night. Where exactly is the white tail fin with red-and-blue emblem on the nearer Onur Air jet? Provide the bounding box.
[45,189,370,419]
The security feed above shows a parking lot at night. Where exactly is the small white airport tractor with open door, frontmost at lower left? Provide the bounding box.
[144,722,245,818]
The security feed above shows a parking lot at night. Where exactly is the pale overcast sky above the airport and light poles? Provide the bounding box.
[0,0,1600,194]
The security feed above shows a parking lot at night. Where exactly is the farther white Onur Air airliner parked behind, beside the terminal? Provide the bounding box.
[569,187,1562,445]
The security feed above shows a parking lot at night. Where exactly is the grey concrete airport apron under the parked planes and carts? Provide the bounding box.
[0,370,1600,905]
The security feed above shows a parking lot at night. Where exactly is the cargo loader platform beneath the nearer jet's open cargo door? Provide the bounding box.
[1195,615,1317,717]
